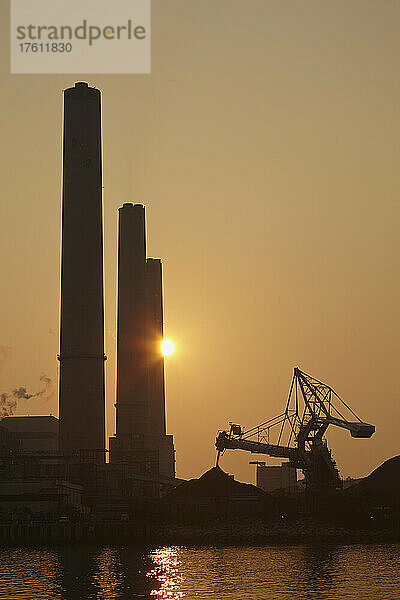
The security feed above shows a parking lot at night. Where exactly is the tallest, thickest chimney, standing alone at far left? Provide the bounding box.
[59,82,105,460]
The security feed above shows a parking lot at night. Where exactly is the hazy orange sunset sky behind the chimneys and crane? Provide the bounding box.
[0,0,400,481]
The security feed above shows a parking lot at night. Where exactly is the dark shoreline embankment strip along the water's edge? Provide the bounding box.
[0,521,400,548]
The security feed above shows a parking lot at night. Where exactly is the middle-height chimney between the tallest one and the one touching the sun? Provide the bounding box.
[110,203,148,471]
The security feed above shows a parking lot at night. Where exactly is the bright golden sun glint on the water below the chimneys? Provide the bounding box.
[147,548,185,600]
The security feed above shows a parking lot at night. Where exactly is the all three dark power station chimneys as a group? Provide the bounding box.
[59,83,175,478]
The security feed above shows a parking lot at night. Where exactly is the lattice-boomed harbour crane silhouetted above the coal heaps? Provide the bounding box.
[215,367,375,489]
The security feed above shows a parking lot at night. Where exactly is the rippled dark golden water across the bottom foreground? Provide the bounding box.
[0,544,400,600]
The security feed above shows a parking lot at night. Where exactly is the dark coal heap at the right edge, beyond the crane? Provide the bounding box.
[345,456,400,504]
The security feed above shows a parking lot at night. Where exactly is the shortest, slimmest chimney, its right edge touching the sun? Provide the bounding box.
[146,258,166,436]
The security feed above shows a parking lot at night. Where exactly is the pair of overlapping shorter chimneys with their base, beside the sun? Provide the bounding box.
[110,204,175,478]
